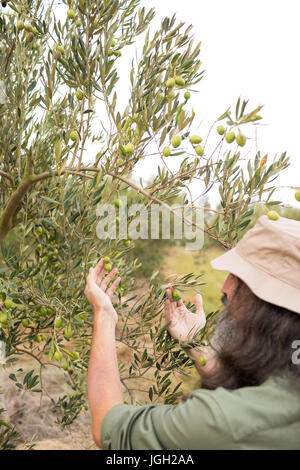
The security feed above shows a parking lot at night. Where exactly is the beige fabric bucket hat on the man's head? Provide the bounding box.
[211,215,300,313]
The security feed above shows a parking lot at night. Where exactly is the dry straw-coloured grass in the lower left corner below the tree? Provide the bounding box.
[0,361,97,450]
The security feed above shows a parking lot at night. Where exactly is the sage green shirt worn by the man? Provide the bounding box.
[101,377,300,450]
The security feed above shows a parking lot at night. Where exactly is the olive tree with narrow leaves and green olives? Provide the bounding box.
[0,0,288,442]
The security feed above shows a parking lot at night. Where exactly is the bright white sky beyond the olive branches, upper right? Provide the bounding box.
[117,0,300,204]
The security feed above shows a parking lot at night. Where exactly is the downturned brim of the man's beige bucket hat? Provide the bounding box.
[210,248,300,313]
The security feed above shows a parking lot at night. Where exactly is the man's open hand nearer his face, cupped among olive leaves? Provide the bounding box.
[165,285,206,341]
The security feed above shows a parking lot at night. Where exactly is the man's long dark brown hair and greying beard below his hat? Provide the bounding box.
[201,278,300,390]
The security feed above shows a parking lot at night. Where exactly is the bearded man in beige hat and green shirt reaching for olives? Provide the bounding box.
[85,216,300,450]
